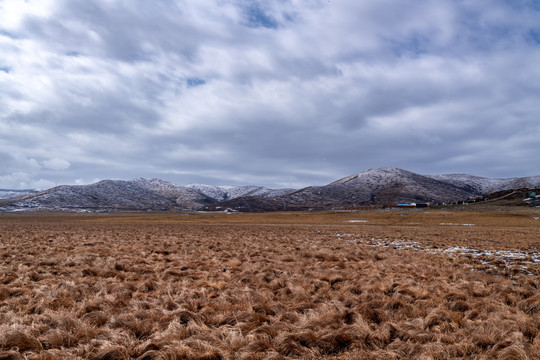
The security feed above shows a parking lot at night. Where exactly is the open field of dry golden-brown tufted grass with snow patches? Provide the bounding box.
[0,208,540,360]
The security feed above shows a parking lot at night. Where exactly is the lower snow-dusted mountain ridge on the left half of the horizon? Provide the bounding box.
[0,178,296,211]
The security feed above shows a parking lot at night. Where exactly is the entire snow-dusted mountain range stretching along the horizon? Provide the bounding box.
[0,167,540,212]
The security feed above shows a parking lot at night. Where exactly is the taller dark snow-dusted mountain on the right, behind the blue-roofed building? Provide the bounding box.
[202,167,540,211]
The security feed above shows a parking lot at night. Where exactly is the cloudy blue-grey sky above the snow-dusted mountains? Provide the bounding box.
[0,0,540,189]
